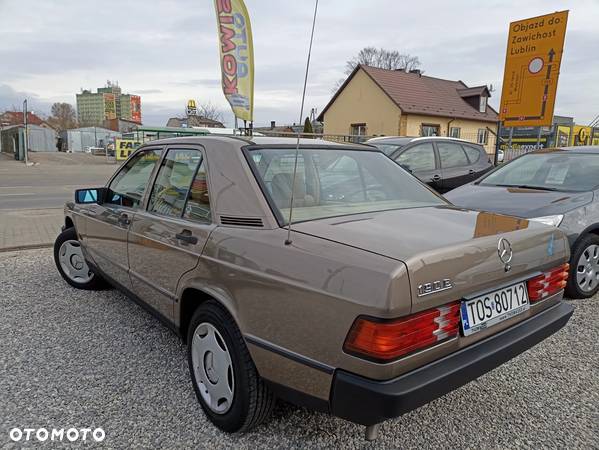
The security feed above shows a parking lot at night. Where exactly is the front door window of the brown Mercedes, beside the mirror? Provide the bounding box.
[104,149,162,208]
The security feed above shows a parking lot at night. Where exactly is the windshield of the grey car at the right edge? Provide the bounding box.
[480,152,599,192]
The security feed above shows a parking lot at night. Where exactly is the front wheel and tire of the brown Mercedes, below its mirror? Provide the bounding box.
[54,227,108,290]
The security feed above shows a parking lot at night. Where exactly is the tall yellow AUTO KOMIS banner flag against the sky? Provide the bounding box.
[214,0,254,122]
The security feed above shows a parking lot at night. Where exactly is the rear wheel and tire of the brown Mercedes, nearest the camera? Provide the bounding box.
[187,300,275,433]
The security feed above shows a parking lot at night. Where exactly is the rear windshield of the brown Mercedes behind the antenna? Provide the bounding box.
[249,148,446,225]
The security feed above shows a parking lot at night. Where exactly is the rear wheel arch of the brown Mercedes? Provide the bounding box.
[175,285,241,344]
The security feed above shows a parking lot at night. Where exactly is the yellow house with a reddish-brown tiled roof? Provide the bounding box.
[318,65,499,153]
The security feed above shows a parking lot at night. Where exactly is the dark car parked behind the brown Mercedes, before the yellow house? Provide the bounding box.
[366,136,493,193]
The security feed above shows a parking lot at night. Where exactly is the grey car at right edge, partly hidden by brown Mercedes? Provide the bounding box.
[446,147,599,298]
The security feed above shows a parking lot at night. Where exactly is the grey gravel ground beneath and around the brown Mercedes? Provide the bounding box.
[0,249,599,449]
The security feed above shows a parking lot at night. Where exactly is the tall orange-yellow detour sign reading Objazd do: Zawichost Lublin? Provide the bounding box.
[499,11,568,127]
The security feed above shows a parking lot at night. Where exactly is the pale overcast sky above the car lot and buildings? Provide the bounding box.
[0,0,599,126]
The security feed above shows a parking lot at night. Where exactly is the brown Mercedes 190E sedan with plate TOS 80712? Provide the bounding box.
[54,136,572,438]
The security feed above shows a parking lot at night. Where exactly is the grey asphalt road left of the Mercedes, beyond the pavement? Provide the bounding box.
[0,153,117,210]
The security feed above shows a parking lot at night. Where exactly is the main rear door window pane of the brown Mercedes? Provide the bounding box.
[148,149,202,217]
